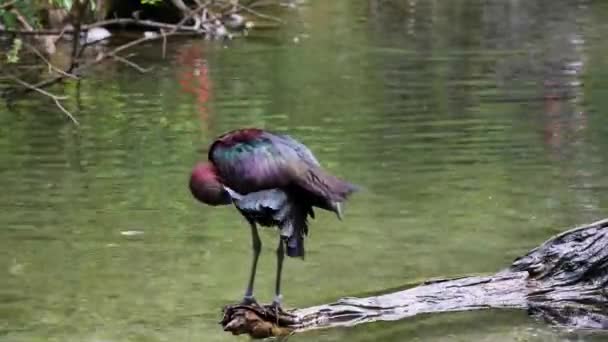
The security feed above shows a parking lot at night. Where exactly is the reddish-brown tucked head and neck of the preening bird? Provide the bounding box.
[190,163,232,206]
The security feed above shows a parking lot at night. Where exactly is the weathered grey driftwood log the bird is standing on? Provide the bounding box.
[221,219,608,338]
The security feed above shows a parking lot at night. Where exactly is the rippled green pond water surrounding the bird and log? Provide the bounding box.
[0,0,608,342]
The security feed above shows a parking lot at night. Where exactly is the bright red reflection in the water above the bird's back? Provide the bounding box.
[176,45,212,132]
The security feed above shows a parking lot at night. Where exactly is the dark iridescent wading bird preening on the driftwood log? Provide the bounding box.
[190,128,356,309]
